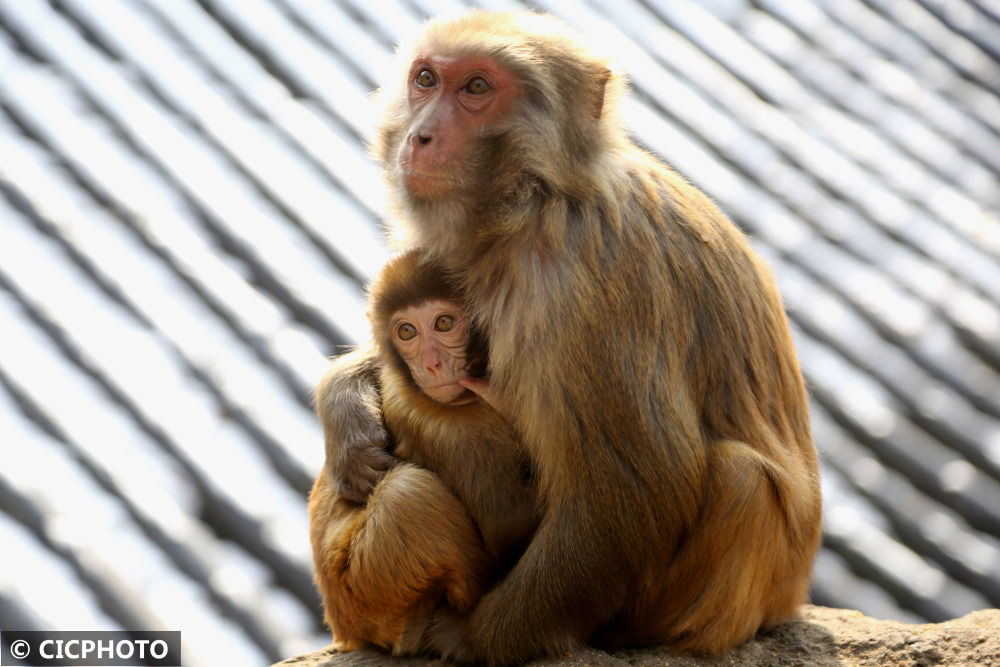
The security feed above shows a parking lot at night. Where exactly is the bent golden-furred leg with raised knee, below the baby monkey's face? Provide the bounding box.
[309,464,487,653]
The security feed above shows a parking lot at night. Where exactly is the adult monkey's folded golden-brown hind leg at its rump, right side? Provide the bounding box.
[636,441,820,653]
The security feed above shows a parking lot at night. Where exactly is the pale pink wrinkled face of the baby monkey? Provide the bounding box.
[389,300,469,404]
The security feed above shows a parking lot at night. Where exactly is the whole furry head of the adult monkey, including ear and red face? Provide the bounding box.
[373,13,612,243]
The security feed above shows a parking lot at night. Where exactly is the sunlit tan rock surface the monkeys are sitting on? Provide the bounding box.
[273,605,1000,667]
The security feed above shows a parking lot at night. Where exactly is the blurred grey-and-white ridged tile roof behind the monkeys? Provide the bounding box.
[0,0,1000,665]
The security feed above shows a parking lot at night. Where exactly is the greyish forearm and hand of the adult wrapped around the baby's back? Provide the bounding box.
[316,344,396,503]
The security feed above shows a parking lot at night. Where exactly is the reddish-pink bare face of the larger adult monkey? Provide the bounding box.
[397,55,518,199]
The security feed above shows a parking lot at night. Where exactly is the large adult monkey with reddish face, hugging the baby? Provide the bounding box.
[317,13,820,664]
